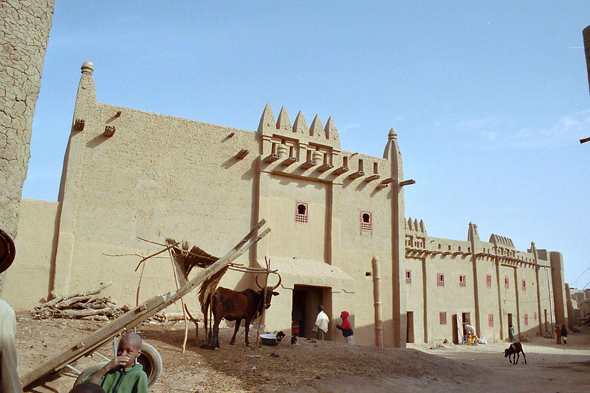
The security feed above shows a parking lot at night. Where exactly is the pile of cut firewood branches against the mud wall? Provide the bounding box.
[35,281,129,321]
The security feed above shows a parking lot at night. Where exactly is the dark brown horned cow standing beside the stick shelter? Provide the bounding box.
[205,276,281,348]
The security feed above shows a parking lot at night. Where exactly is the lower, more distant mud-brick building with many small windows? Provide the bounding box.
[406,219,560,343]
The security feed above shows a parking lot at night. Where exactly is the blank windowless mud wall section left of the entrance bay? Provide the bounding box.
[48,62,257,311]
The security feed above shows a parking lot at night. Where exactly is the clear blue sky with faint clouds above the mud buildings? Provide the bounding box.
[23,0,590,288]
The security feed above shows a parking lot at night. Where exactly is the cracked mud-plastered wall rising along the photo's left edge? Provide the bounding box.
[0,0,55,295]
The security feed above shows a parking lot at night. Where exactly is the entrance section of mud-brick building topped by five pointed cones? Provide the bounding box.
[256,106,403,346]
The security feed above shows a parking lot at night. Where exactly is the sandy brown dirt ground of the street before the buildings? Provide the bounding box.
[17,314,590,393]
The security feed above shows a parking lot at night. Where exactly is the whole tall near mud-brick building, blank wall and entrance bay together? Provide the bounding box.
[6,62,405,346]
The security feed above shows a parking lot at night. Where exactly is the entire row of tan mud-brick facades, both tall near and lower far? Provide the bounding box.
[5,62,564,347]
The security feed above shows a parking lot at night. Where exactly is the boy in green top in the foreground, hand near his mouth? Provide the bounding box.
[88,333,148,393]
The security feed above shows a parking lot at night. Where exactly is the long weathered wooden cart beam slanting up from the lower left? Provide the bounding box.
[21,219,270,388]
